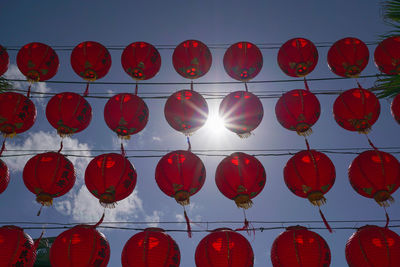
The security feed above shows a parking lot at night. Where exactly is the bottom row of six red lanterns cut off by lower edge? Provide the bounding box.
[0,221,400,267]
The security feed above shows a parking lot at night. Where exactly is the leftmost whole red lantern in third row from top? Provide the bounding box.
[22,152,76,206]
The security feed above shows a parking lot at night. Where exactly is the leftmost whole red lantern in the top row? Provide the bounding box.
[17,43,60,82]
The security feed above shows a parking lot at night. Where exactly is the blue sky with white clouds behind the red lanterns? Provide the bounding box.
[0,0,400,267]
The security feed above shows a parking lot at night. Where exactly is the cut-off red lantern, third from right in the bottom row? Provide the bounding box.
[195,228,254,267]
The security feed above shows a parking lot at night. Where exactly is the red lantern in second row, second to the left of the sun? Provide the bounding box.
[104,93,149,139]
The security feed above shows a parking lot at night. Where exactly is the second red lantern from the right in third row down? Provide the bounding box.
[283,150,336,206]
